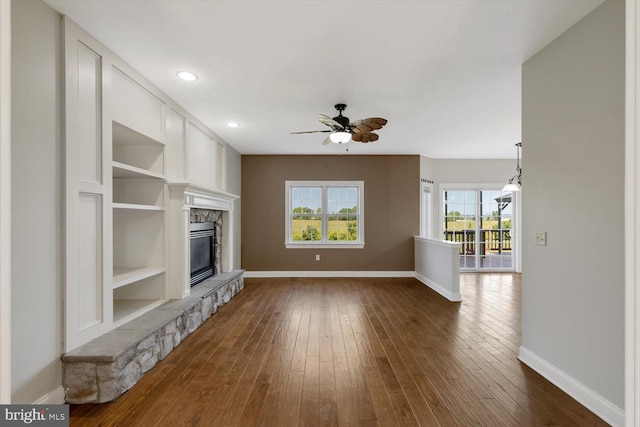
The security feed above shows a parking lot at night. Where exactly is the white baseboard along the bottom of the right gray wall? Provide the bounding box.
[518,346,624,427]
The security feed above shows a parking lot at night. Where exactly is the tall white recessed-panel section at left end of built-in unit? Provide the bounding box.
[64,17,113,352]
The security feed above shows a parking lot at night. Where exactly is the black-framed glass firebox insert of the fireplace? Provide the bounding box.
[190,222,216,286]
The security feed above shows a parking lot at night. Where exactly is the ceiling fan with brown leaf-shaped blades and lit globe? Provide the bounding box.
[291,104,387,145]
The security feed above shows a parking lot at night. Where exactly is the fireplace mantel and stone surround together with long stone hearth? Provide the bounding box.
[62,183,244,403]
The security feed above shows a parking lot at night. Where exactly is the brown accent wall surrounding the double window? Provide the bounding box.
[242,156,420,271]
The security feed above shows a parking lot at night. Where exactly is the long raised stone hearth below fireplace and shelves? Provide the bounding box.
[62,270,244,403]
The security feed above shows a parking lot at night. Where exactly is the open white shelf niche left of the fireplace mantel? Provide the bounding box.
[112,121,167,326]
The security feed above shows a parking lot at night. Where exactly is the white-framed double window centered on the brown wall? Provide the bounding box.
[285,181,364,248]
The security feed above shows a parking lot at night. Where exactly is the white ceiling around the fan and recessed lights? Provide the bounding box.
[45,0,602,158]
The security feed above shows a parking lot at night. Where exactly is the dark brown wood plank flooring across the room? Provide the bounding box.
[71,273,606,427]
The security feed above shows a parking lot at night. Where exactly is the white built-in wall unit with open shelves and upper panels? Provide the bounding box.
[64,18,233,352]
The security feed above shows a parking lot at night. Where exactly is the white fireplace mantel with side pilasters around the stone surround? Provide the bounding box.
[166,182,240,299]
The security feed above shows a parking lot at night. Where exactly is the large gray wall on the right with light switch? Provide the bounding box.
[522,1,625,408]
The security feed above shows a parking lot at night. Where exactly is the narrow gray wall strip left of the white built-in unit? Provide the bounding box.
[11,1,63,403]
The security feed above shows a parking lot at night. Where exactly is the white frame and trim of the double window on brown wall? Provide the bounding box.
[284,181,364,249]
